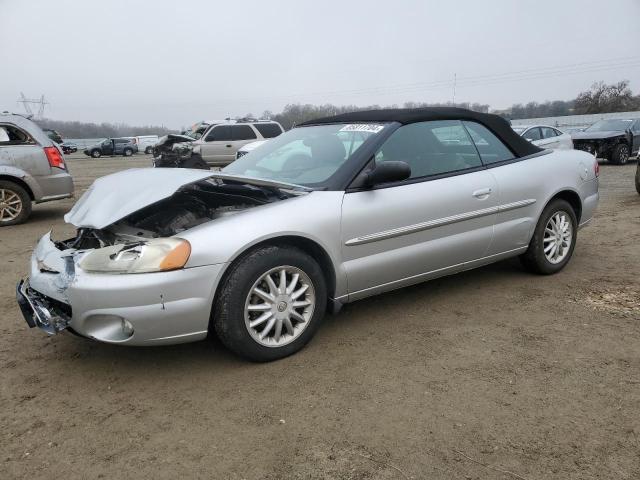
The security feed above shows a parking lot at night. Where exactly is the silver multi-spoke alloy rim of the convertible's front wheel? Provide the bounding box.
[244,266,316,347]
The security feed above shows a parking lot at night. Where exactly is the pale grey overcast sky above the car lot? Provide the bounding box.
[0,0,640,128]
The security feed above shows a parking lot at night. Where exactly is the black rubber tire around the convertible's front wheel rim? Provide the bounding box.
[211,246,327,362]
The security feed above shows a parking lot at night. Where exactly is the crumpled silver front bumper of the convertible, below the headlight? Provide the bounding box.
[16,234,224,345]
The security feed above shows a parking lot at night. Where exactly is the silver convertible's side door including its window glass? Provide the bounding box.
[342,121,498,300]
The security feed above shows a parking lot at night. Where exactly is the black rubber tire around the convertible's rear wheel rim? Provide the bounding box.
[520,198,578,275]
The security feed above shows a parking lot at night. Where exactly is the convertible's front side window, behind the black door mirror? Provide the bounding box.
[375,120,482,178]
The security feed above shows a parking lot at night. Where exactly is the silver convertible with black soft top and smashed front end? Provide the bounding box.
[17,108,598,361]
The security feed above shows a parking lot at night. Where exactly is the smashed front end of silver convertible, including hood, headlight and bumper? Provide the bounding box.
[16,169,306,345]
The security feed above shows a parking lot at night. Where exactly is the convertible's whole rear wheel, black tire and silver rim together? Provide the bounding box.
[520,199,578,275]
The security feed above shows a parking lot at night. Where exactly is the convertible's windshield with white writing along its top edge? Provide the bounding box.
[222,123,386,188]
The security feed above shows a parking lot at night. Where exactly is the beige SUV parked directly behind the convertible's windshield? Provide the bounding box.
[193,120,284,167]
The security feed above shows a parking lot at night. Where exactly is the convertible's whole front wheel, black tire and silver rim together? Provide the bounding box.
[212,246,327,362]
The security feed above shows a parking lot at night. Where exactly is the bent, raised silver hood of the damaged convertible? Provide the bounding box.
[64,168,309,229]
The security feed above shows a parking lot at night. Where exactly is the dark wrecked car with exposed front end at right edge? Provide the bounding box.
[571,119,640,165]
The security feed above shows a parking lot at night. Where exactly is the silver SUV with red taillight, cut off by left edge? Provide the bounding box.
[0,113,73,227]
